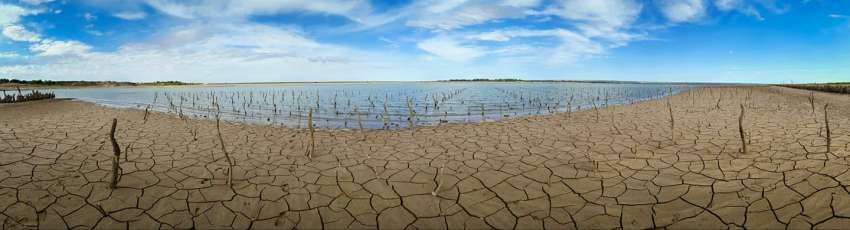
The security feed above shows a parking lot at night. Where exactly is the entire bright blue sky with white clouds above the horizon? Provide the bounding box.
[0,0,850,83]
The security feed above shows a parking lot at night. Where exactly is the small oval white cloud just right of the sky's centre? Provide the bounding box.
[416,36,485,62]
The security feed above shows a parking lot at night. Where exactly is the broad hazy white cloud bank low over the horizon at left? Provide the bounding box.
[0,23,412,82]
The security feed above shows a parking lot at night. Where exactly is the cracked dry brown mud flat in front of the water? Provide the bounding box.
[0,87,850,229]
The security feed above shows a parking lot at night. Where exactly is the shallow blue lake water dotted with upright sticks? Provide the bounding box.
[53,82,692,129]
